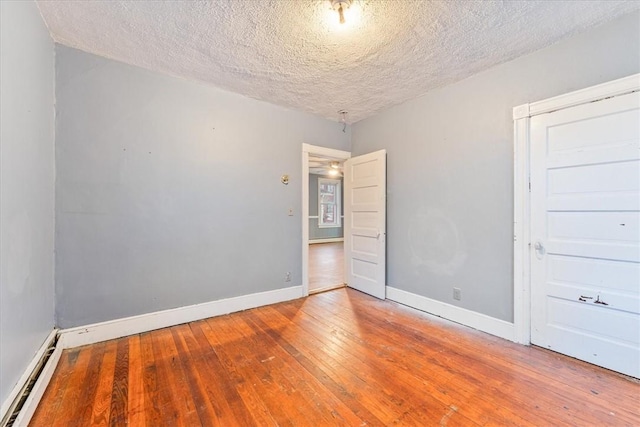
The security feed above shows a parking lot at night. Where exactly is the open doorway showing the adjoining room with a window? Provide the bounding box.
[302,144,351,296]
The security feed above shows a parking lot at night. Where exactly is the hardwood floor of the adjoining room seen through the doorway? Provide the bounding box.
[309,242,344,292]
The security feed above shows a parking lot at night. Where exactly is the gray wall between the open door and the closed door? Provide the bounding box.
[352,13,640,321]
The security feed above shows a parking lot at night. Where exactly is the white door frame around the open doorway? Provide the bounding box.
[300,143,351,297]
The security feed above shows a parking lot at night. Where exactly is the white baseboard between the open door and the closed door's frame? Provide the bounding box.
[387,286,515,341]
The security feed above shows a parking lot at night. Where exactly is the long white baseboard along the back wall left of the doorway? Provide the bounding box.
[60,286,302,348]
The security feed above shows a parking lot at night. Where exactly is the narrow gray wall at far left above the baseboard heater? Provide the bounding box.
[0,2,54,403]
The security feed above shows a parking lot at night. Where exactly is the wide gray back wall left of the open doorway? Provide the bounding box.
[56,45,350,327]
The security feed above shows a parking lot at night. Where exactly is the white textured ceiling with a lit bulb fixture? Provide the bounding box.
[38,0,640,123]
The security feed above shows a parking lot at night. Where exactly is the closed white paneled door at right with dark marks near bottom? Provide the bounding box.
[531,93,640,377]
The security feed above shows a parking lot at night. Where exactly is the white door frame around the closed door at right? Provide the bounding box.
[513,73,640,345]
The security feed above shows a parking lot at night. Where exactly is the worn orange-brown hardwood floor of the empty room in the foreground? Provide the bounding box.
[31,288,640,426]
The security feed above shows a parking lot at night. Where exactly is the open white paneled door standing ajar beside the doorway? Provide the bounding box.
[344,150,387,299]
